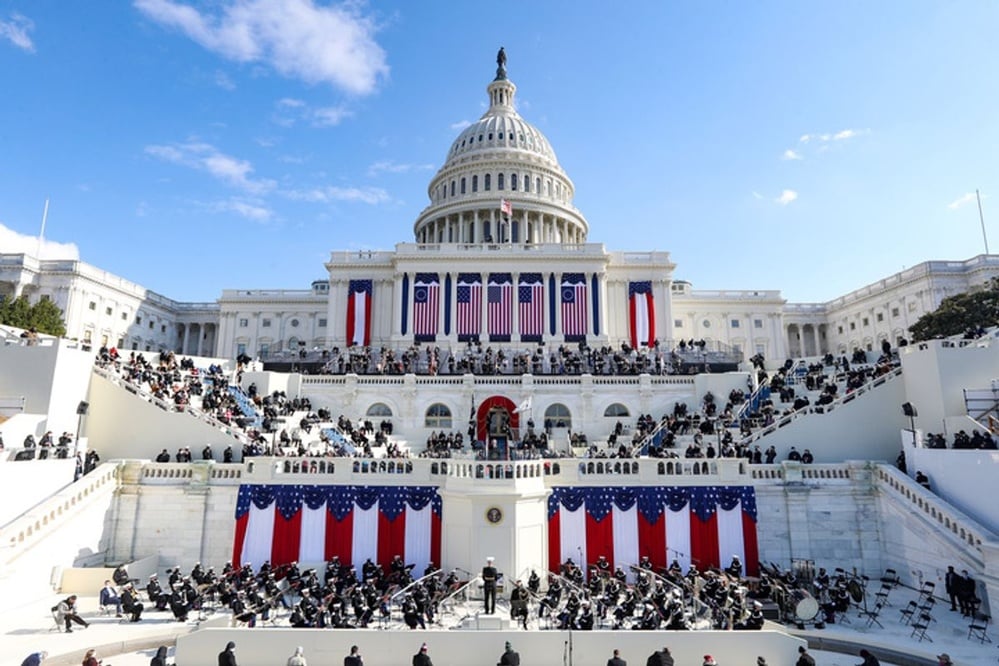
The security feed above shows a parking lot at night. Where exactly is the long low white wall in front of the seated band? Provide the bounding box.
[176,627,805,666]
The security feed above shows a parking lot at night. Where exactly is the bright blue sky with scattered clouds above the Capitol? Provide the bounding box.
[0,0,999,302]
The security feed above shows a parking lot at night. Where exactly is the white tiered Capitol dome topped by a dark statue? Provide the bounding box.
[413,49,589,244]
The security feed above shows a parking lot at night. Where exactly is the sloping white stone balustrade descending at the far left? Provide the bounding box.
[0,463,118,563]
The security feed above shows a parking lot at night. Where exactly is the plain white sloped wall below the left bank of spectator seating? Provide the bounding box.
[84,375,241,460]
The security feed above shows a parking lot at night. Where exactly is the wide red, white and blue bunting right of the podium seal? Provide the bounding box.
[548,486,759,576]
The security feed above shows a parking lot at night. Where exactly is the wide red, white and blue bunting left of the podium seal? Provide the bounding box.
[232,485,443,571]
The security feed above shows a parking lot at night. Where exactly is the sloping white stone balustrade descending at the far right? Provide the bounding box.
[874,465,996,557]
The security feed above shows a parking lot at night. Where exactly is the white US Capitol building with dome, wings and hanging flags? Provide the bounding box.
[0,54,999,360]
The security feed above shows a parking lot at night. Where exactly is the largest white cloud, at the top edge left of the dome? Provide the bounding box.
[134,0,389,95]
